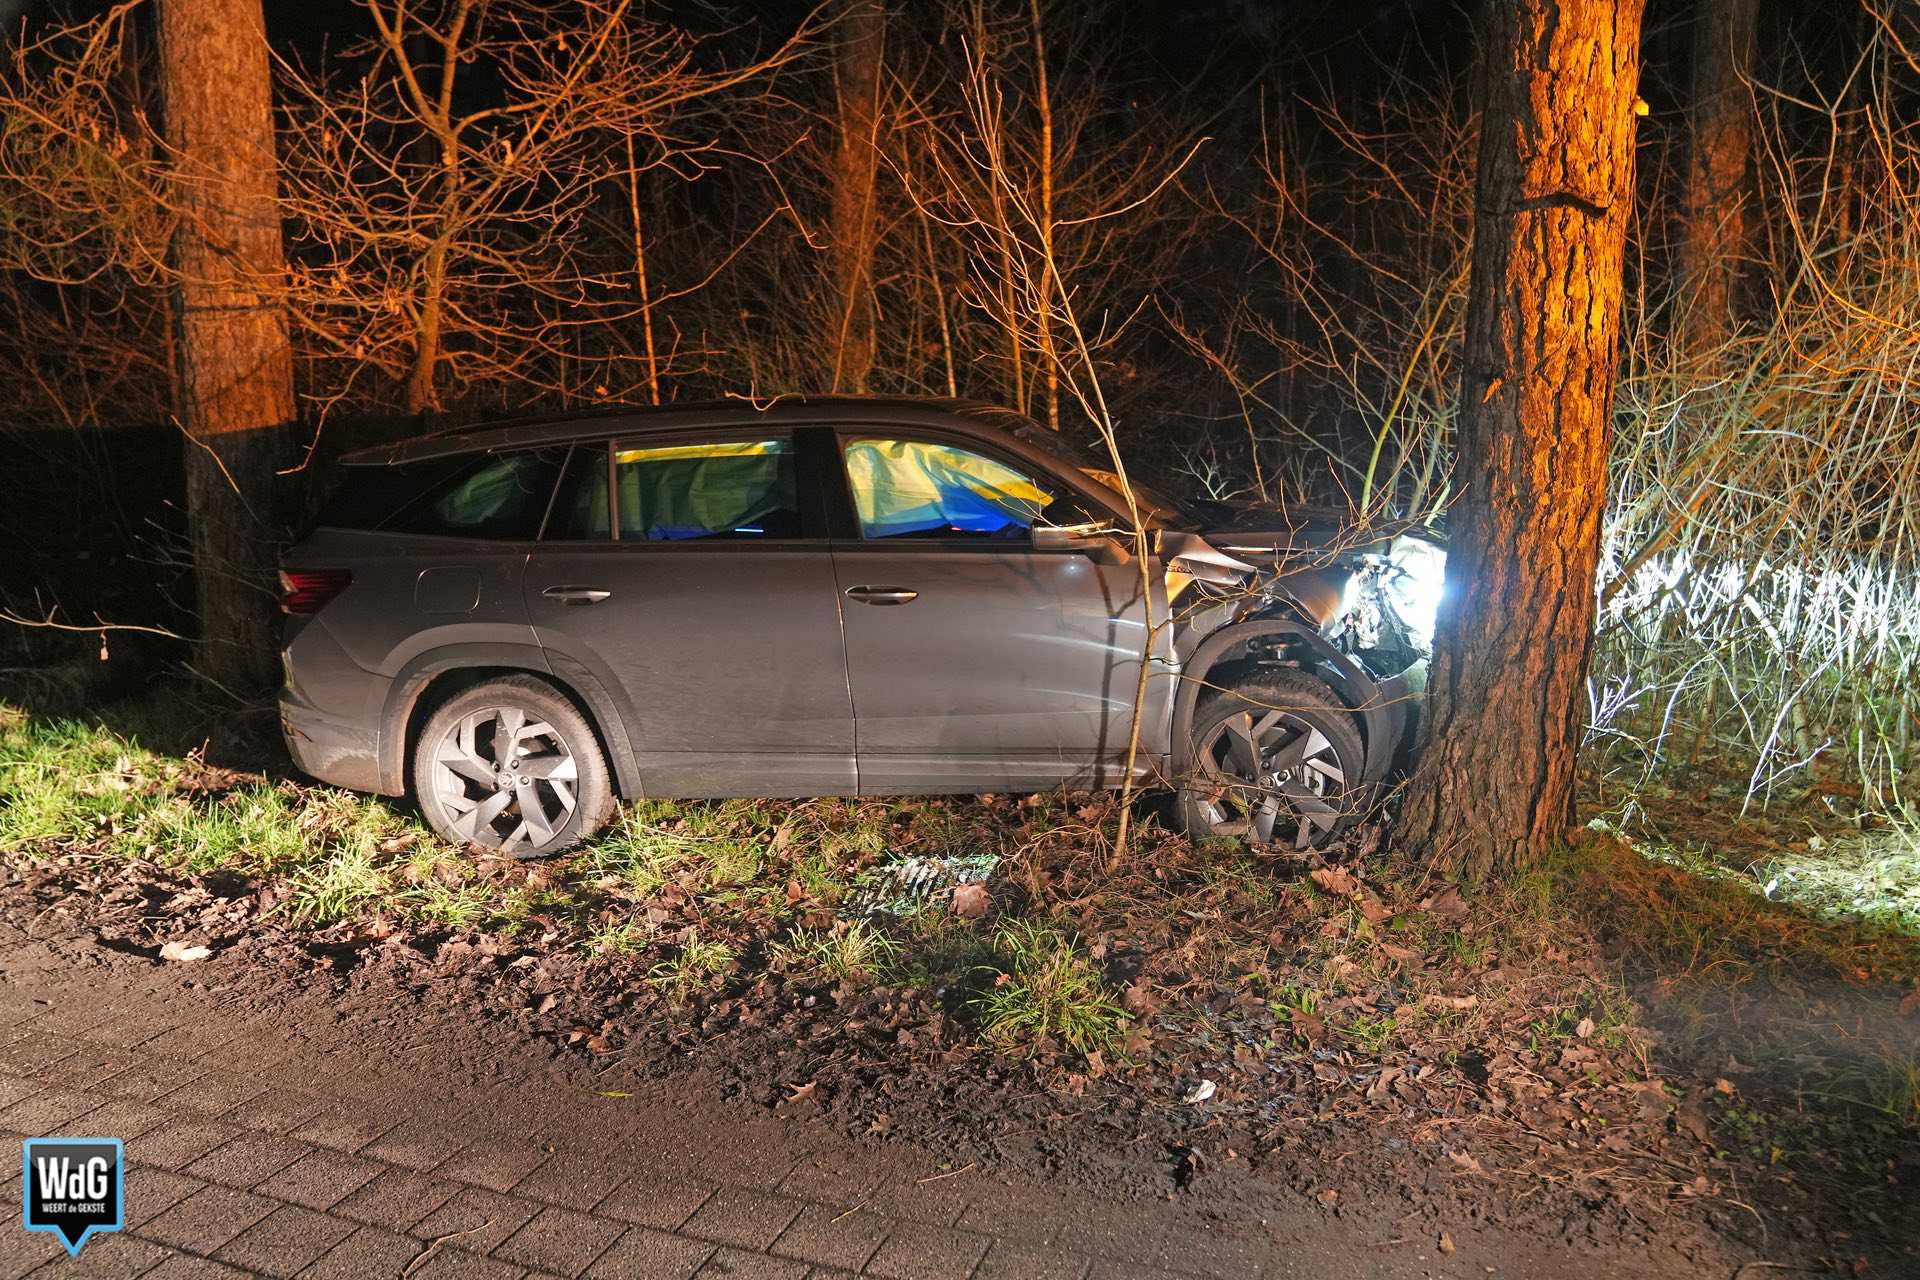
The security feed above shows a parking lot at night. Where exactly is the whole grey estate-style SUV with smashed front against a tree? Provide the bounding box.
[280,399,1442,856]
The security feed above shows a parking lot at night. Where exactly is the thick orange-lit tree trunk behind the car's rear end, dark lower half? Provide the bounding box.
[159,0,294,691]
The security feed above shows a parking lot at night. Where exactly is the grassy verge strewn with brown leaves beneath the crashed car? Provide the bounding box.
[0,690,1920,1119]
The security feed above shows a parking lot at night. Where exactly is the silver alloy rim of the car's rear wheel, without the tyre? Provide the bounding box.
[432,706,580,856]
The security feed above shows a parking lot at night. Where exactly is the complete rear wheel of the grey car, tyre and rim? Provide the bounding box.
[413,676,614,858]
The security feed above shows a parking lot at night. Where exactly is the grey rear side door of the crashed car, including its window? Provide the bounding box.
[526,428,854,796]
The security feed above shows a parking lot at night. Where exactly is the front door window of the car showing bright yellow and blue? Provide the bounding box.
[845,438,1079,539]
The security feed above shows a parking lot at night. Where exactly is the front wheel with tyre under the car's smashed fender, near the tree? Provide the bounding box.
[1179,670,1373,848]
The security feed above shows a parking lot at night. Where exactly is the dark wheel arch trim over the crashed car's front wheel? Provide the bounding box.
[1171,616,1400,783]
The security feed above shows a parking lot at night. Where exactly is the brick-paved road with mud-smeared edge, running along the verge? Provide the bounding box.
[0,932,1697,1280]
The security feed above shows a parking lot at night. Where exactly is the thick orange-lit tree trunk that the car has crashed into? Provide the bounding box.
[1402,0,1642,877]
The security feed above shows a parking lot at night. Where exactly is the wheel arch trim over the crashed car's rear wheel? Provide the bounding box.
[378,645,639,800]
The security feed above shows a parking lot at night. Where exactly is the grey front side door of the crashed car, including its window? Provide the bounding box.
[833,430,1169,794]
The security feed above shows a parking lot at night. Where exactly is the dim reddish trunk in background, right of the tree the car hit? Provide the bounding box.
[1674,0,1759,355]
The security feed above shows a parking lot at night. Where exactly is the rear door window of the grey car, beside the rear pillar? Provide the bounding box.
[612,439,801,543]
